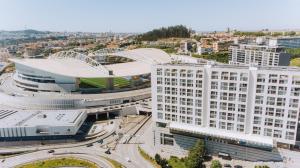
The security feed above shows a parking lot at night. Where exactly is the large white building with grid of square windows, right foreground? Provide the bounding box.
[152,62,300,161]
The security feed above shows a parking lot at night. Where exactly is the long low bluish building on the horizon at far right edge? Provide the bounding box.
[269,37,300,48]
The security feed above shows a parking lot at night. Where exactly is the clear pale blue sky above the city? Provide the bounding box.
[0,0,300,32]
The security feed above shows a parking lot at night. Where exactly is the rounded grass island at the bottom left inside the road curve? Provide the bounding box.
[17,157,97,168]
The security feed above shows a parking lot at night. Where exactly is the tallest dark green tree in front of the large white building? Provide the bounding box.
[185,140,205,168]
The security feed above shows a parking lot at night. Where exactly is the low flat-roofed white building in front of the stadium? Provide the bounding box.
[0,109,87,140]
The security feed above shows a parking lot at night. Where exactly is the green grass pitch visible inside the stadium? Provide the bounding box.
[80,77,130,88]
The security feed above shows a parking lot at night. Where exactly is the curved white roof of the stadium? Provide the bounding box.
[11,48,171,78]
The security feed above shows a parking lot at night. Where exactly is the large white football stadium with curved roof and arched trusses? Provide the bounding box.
[0,48,171,113]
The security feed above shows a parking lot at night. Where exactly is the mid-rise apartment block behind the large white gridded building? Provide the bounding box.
[229,44,291,66]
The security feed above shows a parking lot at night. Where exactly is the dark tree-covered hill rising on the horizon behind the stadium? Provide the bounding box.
[138,25,191,41]
